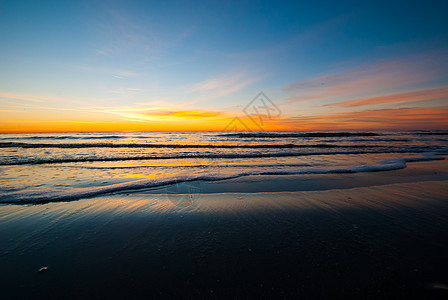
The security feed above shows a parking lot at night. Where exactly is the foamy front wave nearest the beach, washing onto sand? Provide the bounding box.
[0,153,444,204]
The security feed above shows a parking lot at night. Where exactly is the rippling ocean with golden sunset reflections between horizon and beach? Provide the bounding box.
[0,131,448,204]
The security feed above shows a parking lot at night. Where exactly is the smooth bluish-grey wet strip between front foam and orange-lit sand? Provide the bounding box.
[153,156,448,194]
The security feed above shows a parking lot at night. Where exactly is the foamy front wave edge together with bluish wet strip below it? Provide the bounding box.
[0,155,448,205]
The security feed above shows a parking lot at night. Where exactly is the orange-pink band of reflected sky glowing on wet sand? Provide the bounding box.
[0,181,448,226]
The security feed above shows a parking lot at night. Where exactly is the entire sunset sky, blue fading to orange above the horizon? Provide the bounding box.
[0,0,448,133]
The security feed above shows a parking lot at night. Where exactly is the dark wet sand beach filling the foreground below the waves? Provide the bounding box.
[0,161,448,299]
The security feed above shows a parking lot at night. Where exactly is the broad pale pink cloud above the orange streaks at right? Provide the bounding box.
[283,54,446,106]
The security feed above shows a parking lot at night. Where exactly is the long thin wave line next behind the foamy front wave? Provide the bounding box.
[0,148,440,166]
